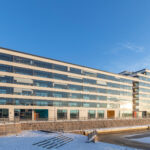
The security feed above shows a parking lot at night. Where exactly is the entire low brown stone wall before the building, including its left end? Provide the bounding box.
[0,118,150,135]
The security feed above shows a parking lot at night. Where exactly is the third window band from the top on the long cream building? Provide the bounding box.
[0,76,132,95]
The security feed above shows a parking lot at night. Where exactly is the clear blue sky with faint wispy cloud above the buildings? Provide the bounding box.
[0,0,150,73]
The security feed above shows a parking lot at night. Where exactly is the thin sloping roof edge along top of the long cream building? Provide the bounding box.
[0,46,134,79]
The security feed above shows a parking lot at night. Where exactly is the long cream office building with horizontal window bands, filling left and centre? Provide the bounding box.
[0,48,138,120]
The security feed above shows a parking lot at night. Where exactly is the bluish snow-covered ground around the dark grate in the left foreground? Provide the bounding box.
[0,131,138,150]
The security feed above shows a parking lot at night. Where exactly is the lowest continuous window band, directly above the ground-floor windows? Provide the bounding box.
[0,98,120,108]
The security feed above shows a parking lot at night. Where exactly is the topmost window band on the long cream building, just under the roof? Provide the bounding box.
[0,53,132,83]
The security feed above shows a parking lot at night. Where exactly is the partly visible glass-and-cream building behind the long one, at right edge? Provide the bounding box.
[121,69,150,117]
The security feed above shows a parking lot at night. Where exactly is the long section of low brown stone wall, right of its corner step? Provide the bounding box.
[21,119,150,131]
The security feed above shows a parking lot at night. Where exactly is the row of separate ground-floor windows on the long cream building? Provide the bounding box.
[0,109,132,120]
